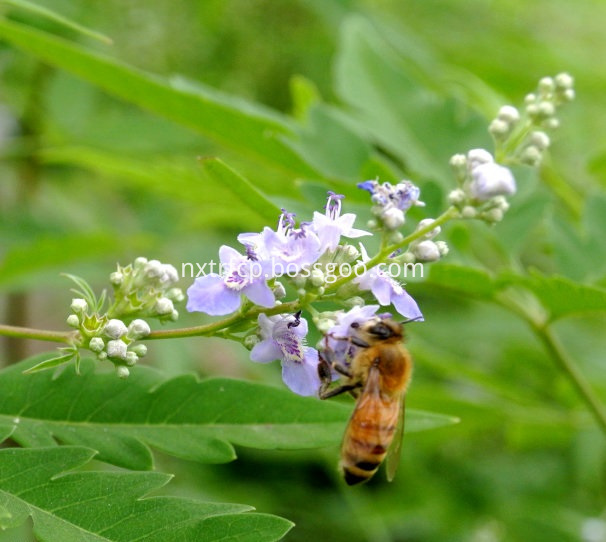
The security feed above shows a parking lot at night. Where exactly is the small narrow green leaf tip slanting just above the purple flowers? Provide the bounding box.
[200,158,281,224]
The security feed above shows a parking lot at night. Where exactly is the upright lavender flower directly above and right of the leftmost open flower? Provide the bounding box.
[238,209,323,276]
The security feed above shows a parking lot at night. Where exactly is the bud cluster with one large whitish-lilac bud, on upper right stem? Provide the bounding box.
[448,149,516,223]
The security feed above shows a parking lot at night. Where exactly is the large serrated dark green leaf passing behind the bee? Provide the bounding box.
[0,358,452,469]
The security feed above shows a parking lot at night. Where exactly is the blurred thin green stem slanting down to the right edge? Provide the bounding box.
[531,322,606,435]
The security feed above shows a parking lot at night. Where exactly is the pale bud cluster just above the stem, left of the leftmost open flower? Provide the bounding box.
[110,258,185,321]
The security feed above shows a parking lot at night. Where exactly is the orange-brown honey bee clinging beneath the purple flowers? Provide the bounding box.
[318,317,412,485]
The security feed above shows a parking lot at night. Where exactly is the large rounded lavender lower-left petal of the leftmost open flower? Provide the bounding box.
[186,273,240,316]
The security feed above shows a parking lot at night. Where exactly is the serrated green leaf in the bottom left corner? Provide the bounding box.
[0,446,292,542]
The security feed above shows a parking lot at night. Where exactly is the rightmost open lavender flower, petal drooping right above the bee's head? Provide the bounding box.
[353,245,423,321]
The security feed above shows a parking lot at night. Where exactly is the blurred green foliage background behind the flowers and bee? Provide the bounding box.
[0,0,606,542]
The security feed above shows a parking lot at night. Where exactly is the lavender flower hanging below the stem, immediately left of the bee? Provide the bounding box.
[250,313,320,396]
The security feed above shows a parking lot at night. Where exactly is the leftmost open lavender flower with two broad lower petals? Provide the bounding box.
[186,245,275,316]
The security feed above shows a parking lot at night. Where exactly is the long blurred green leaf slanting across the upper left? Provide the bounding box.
[0,19,315,177]
